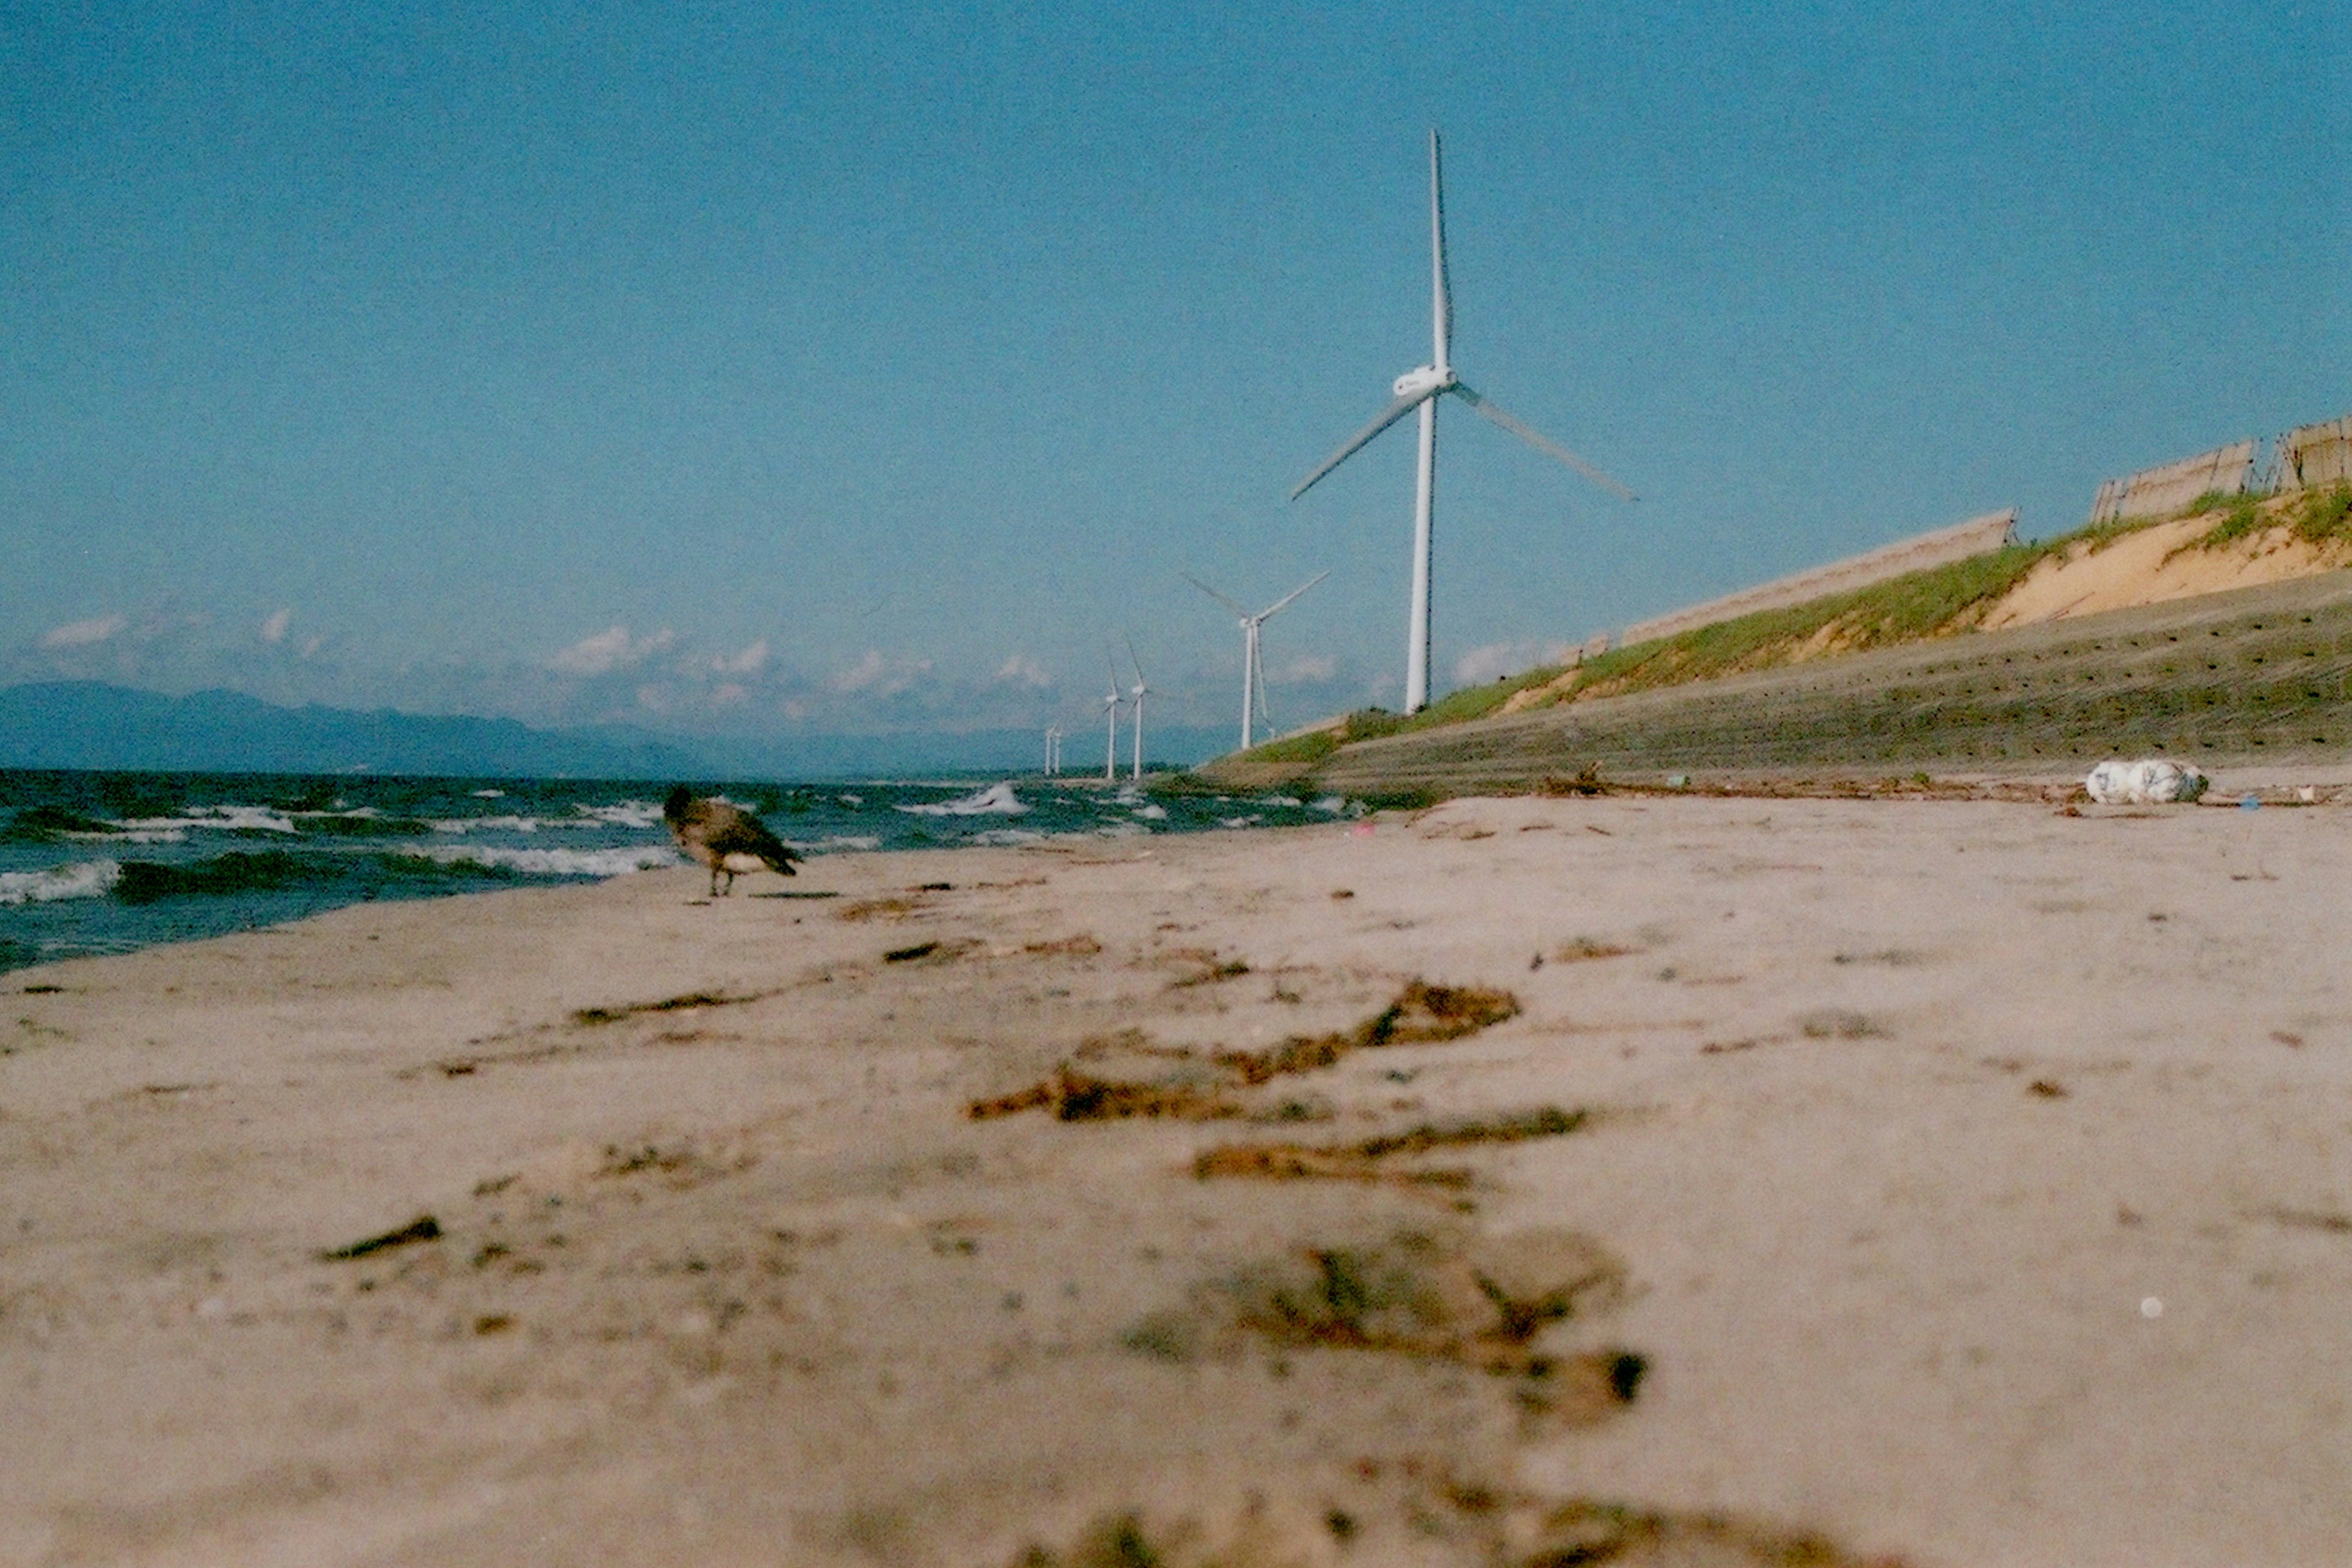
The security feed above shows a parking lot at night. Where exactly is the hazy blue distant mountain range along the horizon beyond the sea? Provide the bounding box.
[0,682,1226,780]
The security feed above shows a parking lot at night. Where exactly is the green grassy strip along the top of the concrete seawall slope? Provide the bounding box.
[1232,484,2352,766]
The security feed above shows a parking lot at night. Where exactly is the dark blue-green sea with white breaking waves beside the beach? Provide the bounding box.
[0,769,1360,971]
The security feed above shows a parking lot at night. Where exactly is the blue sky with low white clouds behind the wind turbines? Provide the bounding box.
[0,0,2352,761]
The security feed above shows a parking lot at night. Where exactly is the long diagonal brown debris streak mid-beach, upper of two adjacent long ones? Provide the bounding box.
[964,980,1520,1121]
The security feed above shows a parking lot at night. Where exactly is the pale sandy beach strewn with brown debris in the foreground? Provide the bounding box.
[0,799,2352,1568]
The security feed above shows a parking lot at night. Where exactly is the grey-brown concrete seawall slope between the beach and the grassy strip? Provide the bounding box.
[1313,571,2352,794]
